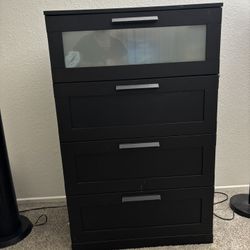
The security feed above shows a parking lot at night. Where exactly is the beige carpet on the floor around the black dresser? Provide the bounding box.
[7,188,250,250]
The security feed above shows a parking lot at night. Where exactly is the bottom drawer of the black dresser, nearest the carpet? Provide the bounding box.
[68,188,213,243]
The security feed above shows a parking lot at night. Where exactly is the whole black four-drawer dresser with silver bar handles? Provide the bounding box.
[45,3,222,250]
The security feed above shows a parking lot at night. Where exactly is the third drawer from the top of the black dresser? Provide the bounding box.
[61,135,215,195]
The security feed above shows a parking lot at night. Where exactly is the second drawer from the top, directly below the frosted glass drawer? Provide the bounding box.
[54,76,218,142]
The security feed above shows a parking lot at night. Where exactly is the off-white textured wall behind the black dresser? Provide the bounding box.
[0,0,250,198]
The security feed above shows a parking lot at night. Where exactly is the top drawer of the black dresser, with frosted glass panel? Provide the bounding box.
[45,4,221,82]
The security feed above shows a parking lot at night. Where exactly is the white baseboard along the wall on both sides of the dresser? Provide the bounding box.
[17,184,249,204]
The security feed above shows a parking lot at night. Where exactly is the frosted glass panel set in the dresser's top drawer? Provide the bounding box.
[62,25,206,68]
